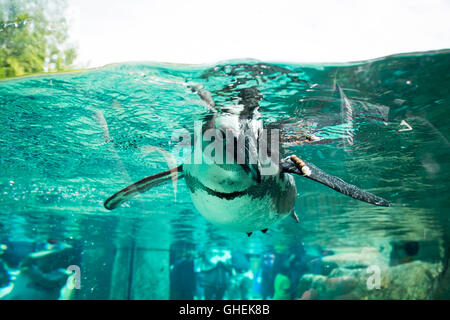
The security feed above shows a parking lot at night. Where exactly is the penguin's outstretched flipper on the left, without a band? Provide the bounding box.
[103,165,183,210]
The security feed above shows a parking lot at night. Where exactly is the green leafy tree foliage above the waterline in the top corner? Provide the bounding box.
[0,0,76,78]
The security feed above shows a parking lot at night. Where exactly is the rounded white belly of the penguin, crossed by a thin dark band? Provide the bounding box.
[185,164,296,232]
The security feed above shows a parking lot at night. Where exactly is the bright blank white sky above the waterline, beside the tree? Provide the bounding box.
[67,0,450,67]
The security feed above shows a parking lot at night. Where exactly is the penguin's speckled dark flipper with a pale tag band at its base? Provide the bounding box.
[280,155,390,207]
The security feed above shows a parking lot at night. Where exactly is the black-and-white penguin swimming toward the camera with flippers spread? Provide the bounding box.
[104,85,389,236]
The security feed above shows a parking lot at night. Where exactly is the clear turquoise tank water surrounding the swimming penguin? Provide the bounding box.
[0,51,450,299]
